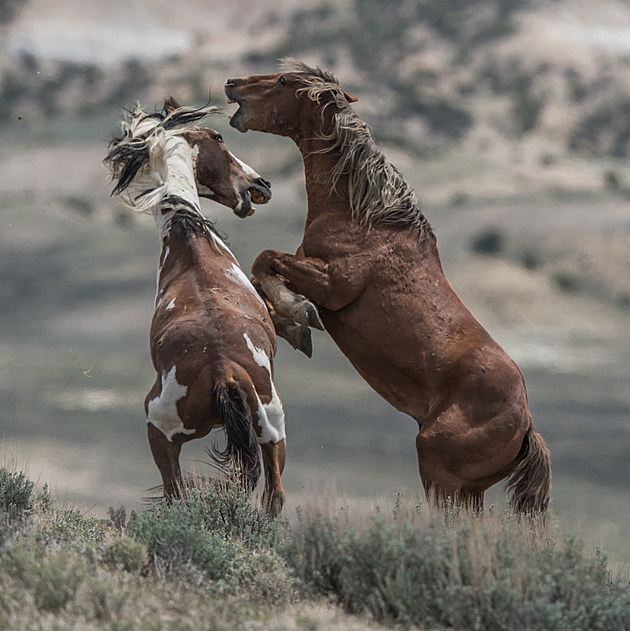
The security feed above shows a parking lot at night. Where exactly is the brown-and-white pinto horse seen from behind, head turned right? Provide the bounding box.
[105,104,286,516]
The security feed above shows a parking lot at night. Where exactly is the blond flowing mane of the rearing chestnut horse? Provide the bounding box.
[283,58,433,236]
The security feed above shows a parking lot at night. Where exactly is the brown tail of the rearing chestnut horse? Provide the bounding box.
[505,426,551,521]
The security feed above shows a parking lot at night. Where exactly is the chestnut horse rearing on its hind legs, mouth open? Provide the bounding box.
[225,60,551,518]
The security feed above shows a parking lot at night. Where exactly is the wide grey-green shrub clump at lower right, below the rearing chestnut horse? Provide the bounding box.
[283,514,630,631]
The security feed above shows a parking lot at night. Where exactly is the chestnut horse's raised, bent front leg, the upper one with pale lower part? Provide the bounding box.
[252,250,365,330]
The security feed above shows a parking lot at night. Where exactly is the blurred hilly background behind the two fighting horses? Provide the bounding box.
[0,0,630,560]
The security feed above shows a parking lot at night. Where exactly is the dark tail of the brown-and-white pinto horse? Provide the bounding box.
[211,381,261,491]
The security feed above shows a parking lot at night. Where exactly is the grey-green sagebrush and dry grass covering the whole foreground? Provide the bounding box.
[0,470,630,631]
